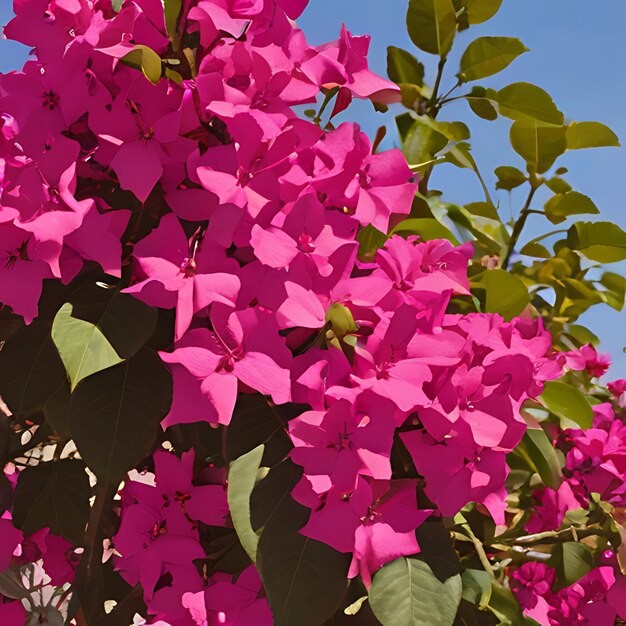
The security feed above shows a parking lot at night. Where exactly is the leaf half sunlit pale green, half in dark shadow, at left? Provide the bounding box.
[52,286,158,389]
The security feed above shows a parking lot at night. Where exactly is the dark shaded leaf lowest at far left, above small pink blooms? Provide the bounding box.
[13,459,91,545]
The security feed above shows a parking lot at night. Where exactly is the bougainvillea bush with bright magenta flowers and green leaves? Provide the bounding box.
[0,0,626,626]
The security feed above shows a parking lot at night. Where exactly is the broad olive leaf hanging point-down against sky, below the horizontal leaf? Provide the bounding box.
[511,120,567,174]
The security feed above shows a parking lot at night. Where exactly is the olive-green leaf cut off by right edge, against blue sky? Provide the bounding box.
[567,222,626,263]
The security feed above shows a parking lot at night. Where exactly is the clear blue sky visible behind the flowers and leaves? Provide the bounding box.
[0,0,626,378]
